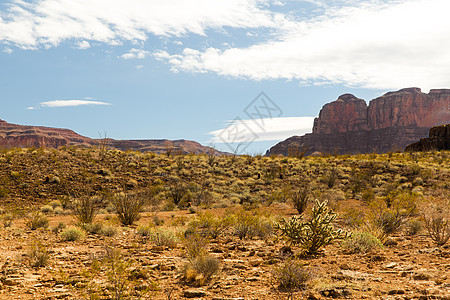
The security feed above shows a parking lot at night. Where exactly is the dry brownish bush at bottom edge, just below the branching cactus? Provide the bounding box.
[272,258,312,299]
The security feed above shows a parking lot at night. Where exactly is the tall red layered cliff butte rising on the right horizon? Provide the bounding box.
[268,88,450,155]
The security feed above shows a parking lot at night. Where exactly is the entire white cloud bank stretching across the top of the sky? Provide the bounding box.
[0,0,450,90]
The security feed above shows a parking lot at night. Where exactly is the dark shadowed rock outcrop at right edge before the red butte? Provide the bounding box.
[405,124,450,152]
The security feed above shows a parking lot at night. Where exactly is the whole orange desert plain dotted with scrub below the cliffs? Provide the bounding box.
[0,147,450,300]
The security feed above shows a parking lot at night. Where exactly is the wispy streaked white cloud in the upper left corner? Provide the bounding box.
[0,0,276,49]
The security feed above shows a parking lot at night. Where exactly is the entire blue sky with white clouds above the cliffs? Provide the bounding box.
[0,0,450,154]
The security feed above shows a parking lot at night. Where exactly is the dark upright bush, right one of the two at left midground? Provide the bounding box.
[113,193,146,226]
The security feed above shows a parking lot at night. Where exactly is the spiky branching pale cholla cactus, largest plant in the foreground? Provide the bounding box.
[276,200,347,255]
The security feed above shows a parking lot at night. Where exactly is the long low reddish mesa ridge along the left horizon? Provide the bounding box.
[0,120,225,154]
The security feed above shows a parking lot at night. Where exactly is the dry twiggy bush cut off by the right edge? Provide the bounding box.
[423,201,450,246]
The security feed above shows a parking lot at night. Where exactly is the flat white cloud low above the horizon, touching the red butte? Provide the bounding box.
[209,117,314,144]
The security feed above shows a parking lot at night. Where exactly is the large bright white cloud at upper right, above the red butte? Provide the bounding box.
[155,0,450,89]
